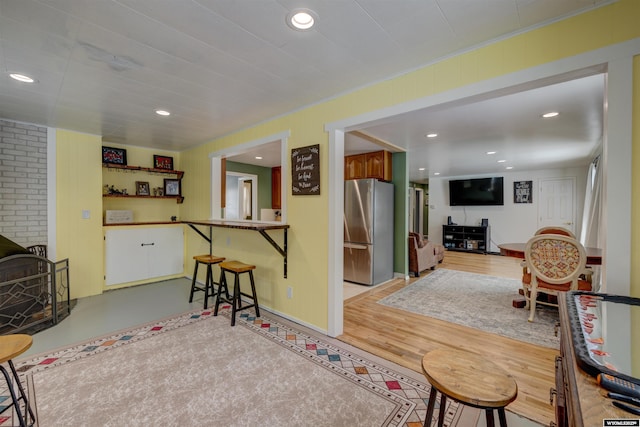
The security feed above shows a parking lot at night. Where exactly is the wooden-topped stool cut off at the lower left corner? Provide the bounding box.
[0,334,36,427]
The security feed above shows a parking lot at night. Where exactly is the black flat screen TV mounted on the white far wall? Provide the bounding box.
[449,176,504,206]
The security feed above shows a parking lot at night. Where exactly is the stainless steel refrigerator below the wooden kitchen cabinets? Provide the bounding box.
[344,179,393,285]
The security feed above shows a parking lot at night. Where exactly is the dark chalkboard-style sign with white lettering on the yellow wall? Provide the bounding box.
[291,144,320,196]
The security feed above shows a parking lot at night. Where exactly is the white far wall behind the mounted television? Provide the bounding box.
[429,166,588,252]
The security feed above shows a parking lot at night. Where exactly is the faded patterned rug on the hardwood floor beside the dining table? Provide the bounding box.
[378,268,560,348]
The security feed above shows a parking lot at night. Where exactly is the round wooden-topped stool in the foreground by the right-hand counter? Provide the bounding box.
[422,348,518,427]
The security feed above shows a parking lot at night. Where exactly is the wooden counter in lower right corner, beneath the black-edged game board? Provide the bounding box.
[556,297,638,427]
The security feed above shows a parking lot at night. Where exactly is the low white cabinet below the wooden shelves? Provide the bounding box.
[105,225,184,286]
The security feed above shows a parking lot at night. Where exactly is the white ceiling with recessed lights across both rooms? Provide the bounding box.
[0,0,612,180]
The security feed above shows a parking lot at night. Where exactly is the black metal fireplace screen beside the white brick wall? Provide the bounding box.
[0,254,71,335]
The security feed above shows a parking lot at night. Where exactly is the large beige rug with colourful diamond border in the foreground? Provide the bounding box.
[0,308,463,427]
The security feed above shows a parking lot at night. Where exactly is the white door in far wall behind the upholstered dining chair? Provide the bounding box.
[538,177,576,234]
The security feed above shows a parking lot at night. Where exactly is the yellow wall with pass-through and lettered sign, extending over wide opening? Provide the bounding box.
[181,0,640,329]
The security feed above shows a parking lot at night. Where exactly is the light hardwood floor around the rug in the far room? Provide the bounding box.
[338,251,559,425]
